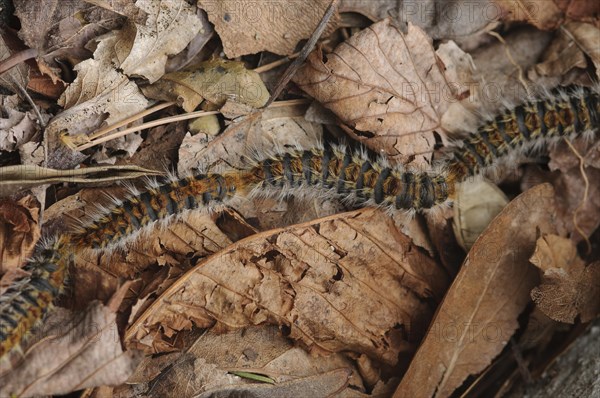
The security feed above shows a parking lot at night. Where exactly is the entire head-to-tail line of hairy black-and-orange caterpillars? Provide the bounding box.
[0,86,600,357]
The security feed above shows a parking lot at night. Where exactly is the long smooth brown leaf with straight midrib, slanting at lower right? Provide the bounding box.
[394,184,555,398]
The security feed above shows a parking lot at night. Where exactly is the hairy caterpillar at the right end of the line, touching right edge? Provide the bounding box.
[448,87,600,182]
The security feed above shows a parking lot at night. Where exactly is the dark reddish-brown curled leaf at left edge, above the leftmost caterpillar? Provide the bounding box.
[0,195,41,275]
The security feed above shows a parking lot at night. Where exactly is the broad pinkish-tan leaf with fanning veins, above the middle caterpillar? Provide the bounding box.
[294,19,454,165]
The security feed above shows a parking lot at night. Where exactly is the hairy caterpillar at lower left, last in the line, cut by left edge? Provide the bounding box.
[0,236,71,358]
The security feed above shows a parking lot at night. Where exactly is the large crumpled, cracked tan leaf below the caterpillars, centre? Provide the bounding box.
[128,209,448,364]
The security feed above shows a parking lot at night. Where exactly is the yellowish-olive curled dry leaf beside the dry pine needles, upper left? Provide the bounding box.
[142,58,269,112]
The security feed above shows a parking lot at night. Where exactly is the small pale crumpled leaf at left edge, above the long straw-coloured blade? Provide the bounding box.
[0,96,38,152]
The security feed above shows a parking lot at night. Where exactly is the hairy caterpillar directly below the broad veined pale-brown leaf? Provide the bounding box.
[251,146,453,211]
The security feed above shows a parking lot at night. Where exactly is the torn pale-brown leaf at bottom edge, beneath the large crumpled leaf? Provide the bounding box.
[118,326,365,398]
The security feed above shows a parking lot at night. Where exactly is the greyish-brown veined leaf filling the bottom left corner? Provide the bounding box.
[0,302,141,396]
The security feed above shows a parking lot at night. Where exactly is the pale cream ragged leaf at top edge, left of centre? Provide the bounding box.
[117,0,202,83]
